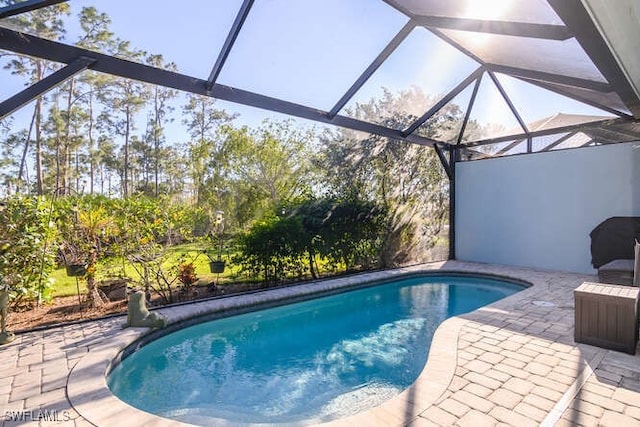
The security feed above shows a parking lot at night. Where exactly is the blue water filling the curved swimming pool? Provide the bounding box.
[108,276,523,425]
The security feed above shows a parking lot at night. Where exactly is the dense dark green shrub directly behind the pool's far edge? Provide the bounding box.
[235,199,387,283]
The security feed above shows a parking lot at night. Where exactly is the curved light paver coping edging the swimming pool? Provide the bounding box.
[67,263,540,427]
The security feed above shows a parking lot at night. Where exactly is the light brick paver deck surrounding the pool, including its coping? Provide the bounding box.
[0,262,640,427]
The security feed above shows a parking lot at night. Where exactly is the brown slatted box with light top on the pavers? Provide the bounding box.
[574,282,640,354]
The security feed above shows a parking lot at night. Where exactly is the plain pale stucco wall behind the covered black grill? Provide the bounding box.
[456,143,640,273]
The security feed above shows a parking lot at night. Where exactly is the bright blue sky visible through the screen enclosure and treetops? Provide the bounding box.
[0,0,620,147]
